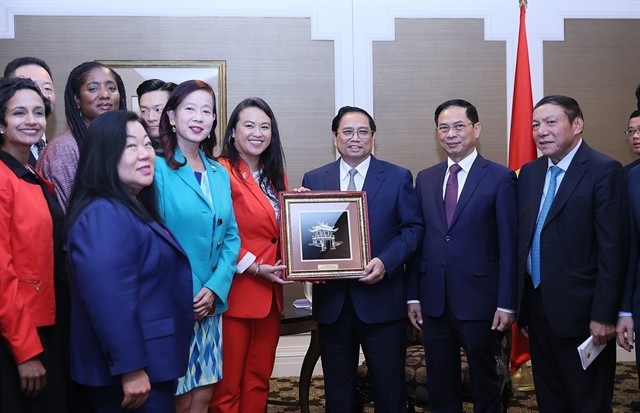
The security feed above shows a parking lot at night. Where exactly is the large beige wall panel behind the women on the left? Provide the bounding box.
[0,16,335,186]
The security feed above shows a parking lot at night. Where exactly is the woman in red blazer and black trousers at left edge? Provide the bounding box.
[0,78,70,413]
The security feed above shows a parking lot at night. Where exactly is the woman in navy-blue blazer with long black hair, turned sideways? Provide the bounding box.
[67,111,193,413]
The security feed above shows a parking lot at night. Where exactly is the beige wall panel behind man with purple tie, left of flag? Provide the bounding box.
[373,19,507,176]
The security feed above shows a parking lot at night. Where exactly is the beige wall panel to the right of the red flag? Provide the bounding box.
[544,19,640,164]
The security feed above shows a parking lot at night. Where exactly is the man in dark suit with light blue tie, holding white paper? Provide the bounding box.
[518,96,629,413]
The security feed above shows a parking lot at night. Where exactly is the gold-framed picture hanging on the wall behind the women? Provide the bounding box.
[99,60,227,149]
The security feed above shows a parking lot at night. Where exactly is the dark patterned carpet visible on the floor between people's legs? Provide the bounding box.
[267,362,640,413]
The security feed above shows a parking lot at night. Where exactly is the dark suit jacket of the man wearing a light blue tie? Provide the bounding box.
[518,141,629,337]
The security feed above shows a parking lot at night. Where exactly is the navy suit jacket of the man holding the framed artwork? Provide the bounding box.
[302,156,423,324]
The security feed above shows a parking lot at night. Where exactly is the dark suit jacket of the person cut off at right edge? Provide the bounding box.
[620,167,640,331]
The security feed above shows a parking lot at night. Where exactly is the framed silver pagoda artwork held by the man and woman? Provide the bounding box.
[280,191,371,280]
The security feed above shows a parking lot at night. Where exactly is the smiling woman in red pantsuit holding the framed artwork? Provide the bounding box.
[210,98,291,413]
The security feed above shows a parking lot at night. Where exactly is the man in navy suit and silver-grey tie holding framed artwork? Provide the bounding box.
[302,106,423,413]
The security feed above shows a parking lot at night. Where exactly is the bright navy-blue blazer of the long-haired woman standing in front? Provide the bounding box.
[67,198,193,386]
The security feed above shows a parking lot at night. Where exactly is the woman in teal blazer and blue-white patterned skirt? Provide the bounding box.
[155,80,240,413]
